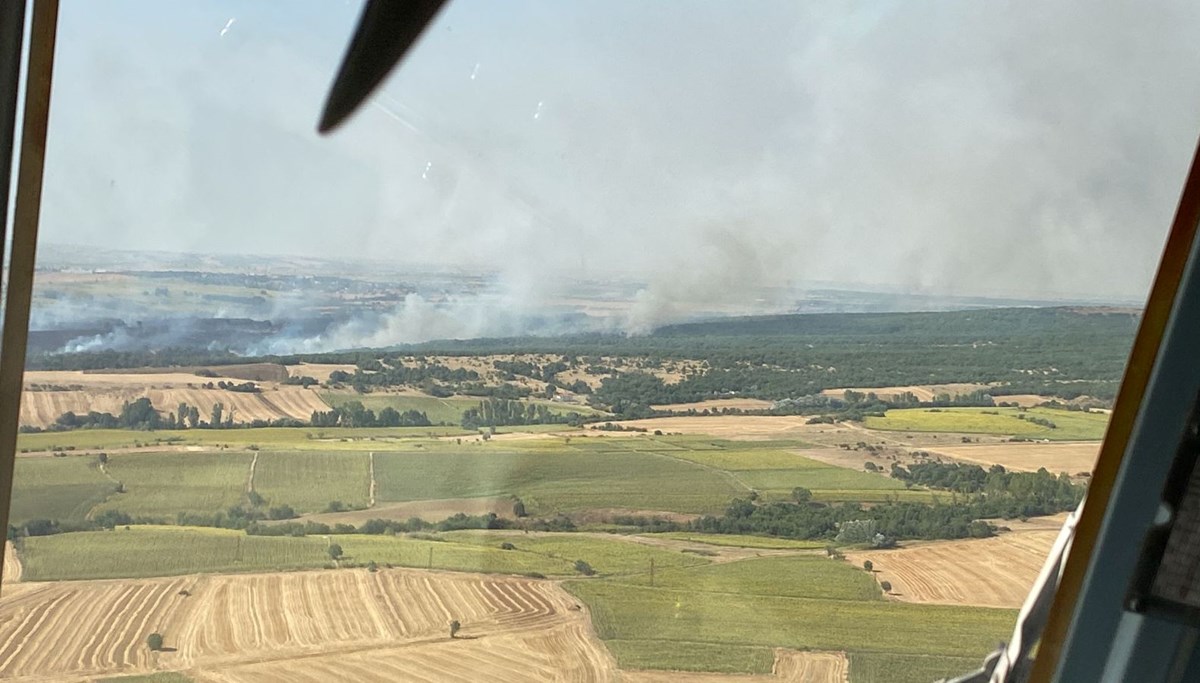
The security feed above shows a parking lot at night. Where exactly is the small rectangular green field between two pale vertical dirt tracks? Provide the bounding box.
[254,451,371,513]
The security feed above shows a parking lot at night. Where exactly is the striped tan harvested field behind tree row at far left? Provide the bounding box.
[20,386,329,427]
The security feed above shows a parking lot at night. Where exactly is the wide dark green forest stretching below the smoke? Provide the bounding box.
[29,307,1139,414]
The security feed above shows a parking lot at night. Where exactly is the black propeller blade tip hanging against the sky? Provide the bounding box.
[317,0,445,133]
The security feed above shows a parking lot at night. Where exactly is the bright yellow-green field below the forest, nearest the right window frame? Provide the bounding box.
[863,408,1109,441]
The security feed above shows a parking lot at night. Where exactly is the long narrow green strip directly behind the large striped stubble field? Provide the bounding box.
[20,526,708,581]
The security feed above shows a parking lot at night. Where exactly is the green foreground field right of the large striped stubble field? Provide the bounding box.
[566,558,1016,681]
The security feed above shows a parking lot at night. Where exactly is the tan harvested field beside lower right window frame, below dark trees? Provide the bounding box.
[846,520,1058,607]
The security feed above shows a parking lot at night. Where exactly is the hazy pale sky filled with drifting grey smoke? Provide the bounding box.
[32,0,1200,302]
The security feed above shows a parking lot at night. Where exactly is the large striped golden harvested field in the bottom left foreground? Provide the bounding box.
[0,570,614,681]
